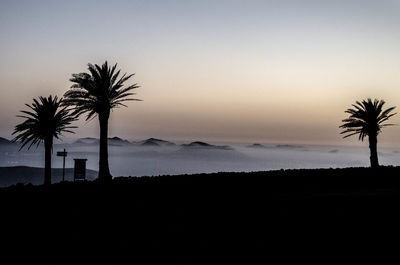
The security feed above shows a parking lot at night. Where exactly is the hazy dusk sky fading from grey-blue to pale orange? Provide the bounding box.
[0,0,400,146]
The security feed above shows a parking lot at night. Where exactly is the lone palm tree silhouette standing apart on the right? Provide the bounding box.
[340,98,396,168]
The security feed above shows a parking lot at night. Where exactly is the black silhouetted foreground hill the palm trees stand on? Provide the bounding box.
[0,167,400,264]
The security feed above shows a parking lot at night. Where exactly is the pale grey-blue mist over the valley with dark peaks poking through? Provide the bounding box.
[0,137,400,186]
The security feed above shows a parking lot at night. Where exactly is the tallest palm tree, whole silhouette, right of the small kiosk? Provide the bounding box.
[64,61,139,180]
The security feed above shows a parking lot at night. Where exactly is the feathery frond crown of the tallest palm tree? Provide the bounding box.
[64,61,139,120]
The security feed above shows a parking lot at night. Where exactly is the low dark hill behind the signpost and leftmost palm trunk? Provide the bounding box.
[0,166,97,187]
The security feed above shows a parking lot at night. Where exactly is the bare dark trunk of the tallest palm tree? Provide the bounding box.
[98,111,112,181]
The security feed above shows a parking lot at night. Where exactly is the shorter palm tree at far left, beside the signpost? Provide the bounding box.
[13,96,76,185]
